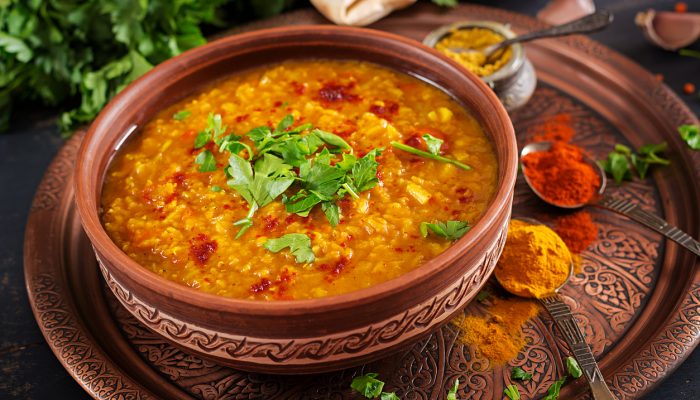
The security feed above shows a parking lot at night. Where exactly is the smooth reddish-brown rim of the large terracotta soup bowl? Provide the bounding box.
[74,25,518,315]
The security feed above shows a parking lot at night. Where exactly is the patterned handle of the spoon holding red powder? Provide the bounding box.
[595,196,700,256]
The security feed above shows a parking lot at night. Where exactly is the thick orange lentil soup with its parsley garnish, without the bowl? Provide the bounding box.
[102,60,498,300]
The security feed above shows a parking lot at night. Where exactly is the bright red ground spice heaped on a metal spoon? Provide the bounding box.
[522,141,600,206]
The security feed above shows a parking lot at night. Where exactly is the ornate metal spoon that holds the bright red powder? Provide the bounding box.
[520,142,700,256]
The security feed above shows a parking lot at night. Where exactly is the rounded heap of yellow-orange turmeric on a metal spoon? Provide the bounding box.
[495,220,572,298]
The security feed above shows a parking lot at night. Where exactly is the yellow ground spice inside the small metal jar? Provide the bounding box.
[435,28,513,76]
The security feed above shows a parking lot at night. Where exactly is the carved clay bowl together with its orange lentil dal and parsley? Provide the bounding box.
[75,26,517,374]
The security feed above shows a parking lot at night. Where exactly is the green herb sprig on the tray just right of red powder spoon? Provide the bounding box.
[598,143,670,185]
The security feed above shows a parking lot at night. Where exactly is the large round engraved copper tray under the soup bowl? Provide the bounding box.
[24,4,700,399]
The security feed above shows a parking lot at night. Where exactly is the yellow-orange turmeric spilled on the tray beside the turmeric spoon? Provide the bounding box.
[453,298,539,365]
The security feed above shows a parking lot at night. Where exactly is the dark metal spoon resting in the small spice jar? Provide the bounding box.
[449,10,613,63]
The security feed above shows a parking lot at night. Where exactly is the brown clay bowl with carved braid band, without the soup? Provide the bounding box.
[75,26,517,374]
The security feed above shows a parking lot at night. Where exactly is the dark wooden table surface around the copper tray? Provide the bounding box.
[0,0,700,399]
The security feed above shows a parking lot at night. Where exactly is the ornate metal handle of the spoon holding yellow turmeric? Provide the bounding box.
[540,294,615,400]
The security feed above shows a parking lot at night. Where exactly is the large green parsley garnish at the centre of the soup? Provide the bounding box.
[193,110,382,238]
